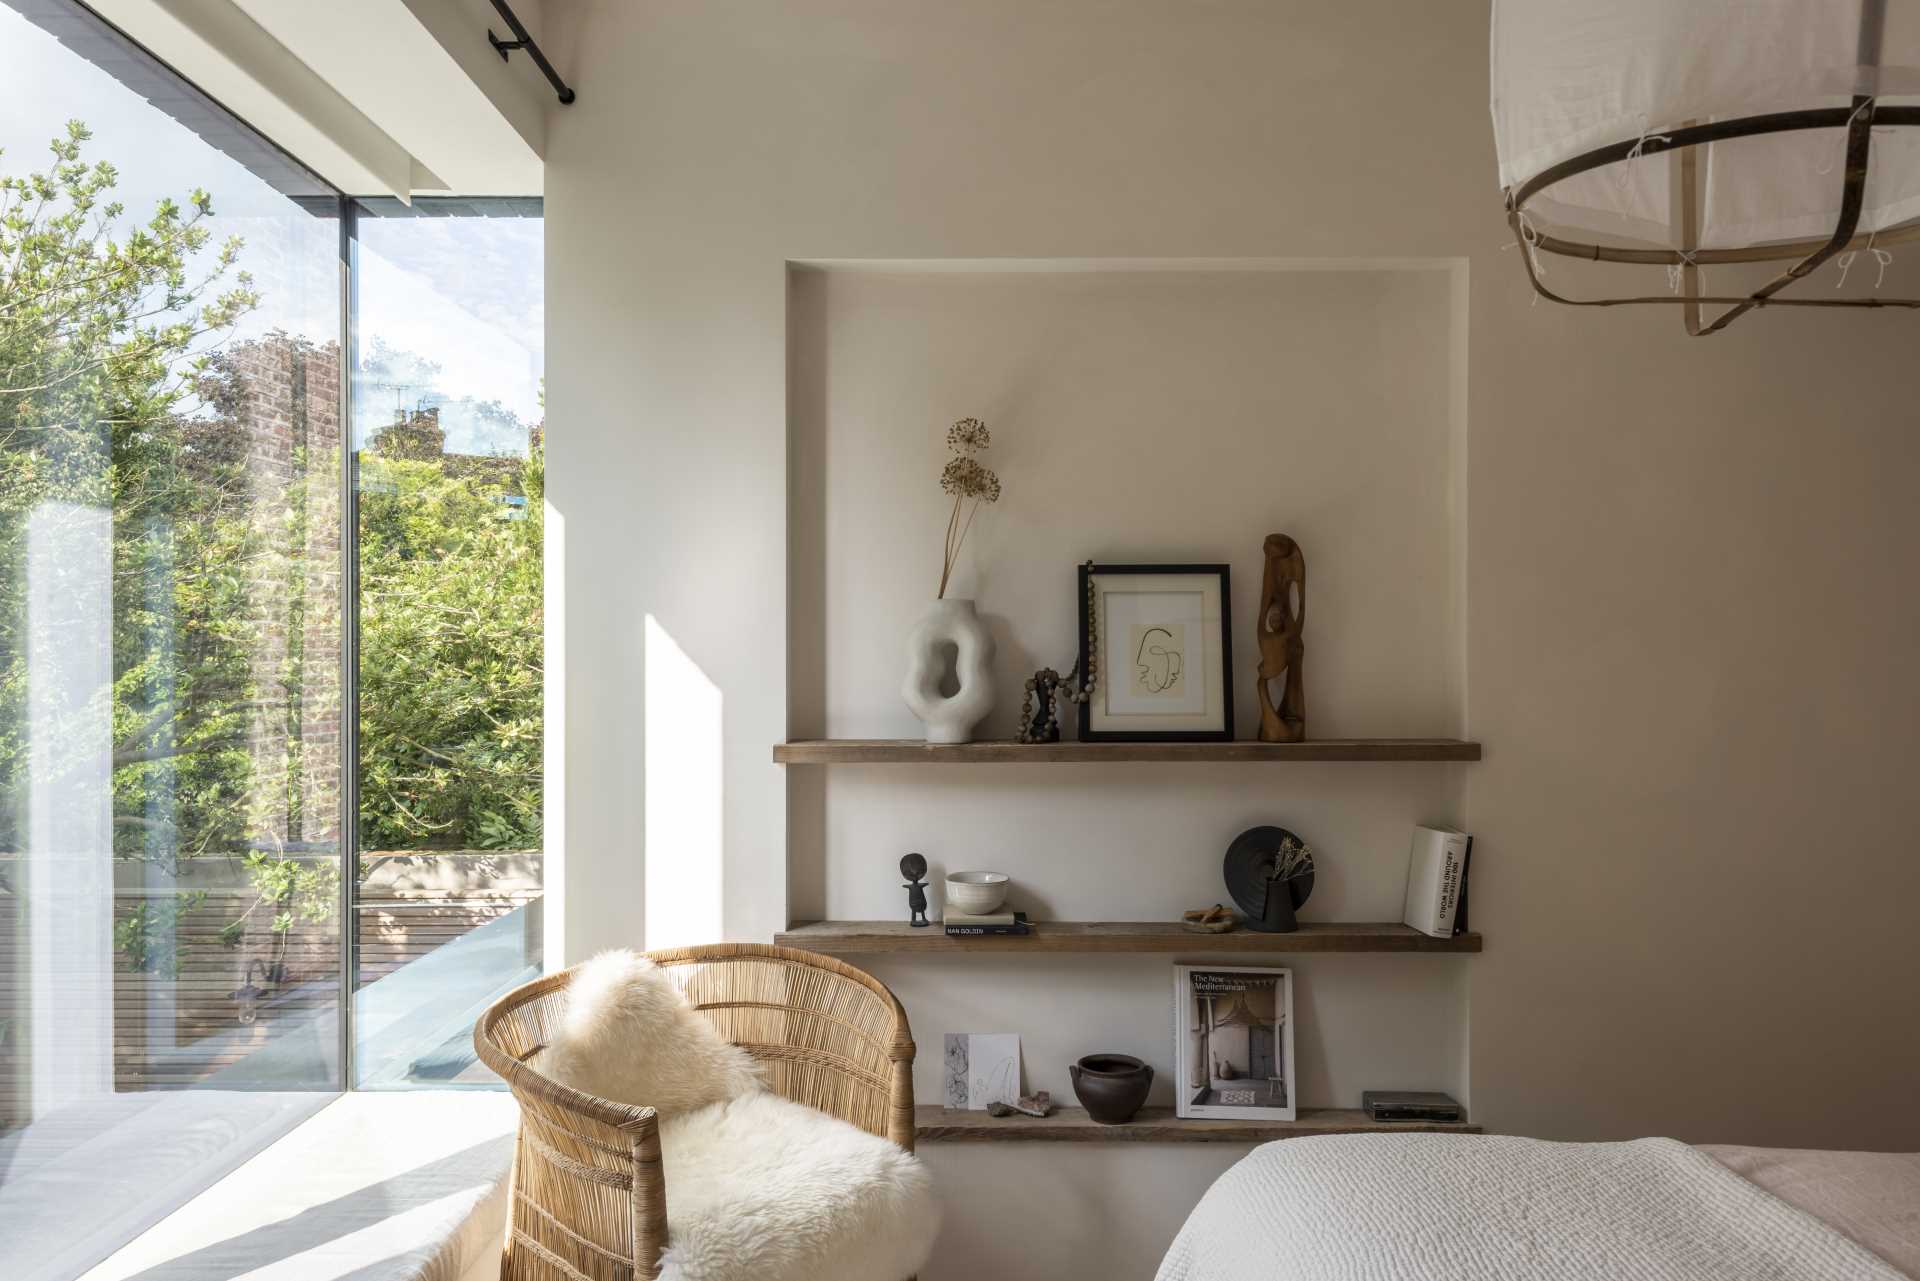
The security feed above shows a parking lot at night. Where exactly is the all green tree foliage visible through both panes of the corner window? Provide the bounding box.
[0,123,543,974]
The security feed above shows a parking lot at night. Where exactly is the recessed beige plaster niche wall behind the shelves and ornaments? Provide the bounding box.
[787,259,1471,1106]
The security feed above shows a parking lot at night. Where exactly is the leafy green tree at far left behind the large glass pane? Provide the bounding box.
[0,121,259,860]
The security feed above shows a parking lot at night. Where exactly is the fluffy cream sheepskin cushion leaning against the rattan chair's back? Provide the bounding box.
[538,951,762,1113]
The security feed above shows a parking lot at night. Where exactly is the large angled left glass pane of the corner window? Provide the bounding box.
[0,0,342,1277]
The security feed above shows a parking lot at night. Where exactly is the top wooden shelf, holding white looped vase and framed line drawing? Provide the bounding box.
[774,737,1480,764]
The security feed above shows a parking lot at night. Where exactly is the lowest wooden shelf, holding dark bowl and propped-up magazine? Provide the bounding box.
[914,1106,1480,1143]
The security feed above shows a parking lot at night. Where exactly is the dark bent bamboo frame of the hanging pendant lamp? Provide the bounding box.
[1503,0,1920,338]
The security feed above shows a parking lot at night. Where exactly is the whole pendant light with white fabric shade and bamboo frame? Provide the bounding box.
[1492,0,1920,336]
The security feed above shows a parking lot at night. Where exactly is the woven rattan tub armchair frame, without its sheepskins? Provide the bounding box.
[474,943,914,1281]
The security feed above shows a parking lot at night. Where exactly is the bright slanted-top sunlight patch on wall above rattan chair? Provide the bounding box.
[643,615,724,949]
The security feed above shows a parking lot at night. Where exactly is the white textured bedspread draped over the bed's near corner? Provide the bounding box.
[1158,1135,1905,1281]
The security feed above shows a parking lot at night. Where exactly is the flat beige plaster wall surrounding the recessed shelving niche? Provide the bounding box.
[547,0,1920,1277]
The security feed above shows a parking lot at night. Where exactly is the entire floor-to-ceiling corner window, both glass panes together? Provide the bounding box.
[0,0,543,1281]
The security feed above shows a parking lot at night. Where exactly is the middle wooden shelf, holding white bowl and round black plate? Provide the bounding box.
[774,920,1480,956]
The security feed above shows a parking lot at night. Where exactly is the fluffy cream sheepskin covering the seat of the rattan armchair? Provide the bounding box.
[660,1093,939,1281]
